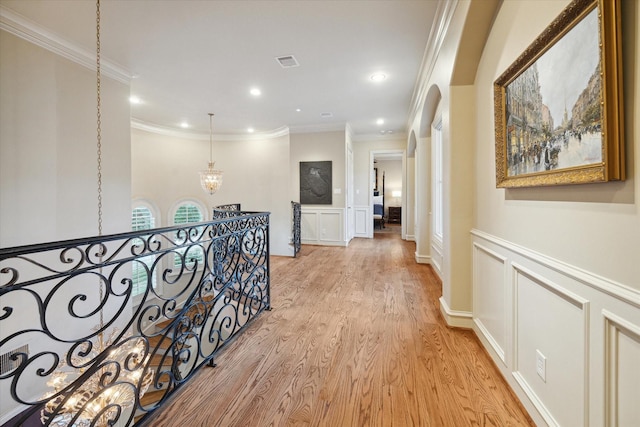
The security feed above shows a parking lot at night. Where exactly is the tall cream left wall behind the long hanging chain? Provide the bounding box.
[0,31,131,247]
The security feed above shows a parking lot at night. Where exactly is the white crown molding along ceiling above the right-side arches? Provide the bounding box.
[407,0,458,129]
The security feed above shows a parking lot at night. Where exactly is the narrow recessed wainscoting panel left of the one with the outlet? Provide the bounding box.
[473,243,510,364]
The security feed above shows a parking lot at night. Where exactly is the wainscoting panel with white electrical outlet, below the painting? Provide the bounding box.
[512,263,589,426]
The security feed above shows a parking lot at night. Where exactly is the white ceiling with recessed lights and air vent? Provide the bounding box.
[0,0,438,137]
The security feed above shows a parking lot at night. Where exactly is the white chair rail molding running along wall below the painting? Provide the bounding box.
[471,229,640,308]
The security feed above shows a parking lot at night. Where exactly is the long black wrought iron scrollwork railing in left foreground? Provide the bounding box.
[0,211,270,426]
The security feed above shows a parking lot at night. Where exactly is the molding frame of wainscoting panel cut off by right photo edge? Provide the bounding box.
[602,310,640,427]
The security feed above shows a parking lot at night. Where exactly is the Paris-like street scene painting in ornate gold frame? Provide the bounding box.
[494,0,625,188]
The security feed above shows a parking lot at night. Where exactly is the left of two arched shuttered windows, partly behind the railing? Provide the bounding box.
[131,203,156,297]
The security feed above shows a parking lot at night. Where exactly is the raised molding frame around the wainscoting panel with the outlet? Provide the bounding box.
[511,262,591,426]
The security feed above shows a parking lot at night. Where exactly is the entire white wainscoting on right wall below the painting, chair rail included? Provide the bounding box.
[471,230,640,427]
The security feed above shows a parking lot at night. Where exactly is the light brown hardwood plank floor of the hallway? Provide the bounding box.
[145,234,533,427]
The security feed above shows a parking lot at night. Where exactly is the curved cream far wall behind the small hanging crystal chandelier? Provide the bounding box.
[131,129,293,256]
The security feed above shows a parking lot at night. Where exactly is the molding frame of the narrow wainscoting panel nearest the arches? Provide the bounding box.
[472,242,510,366]
